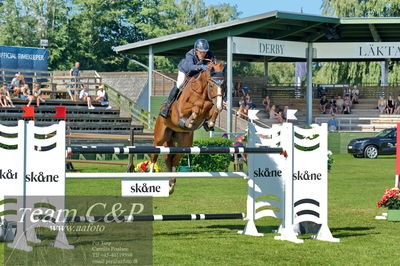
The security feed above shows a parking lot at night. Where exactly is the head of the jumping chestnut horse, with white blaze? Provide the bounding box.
[207,62,224,112]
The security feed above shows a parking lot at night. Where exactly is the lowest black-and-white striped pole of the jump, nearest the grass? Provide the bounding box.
[66,213,244,223]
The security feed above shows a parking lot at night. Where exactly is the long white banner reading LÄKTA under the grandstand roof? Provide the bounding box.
[313,42,400,59]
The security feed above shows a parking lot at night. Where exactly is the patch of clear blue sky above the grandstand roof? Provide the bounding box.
[205,0,322,18]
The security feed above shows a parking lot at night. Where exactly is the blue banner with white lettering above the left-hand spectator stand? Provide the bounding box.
[0,45,49,71]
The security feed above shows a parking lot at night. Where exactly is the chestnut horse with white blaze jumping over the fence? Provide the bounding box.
[150,62,224,193]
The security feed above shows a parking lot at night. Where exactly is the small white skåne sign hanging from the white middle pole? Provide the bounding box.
[121,180,169,197]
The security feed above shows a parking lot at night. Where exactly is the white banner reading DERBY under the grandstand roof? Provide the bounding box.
[232,37,307,58]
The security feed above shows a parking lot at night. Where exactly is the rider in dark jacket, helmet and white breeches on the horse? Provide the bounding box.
[160,39,217,118]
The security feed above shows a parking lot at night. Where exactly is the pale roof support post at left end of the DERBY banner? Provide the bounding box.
[226,36,233,134]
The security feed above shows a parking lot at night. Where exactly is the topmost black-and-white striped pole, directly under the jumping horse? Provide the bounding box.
[67,146,283,154]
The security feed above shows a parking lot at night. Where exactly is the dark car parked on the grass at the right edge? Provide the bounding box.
[347,128,396,159]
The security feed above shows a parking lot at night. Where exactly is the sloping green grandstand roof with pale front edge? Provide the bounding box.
[114,11,400,62]
